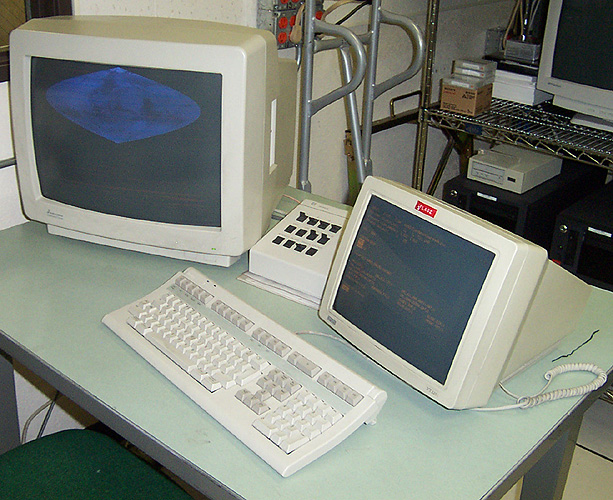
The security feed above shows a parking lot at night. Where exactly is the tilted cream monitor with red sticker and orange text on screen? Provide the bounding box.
[320,177,591,409]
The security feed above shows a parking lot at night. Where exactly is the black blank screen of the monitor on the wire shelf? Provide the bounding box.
[552,0,613,90]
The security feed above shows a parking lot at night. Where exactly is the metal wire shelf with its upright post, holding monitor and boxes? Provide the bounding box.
[413,0,613,189]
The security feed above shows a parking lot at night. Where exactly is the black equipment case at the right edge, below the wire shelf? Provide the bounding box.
[549,183,613,290]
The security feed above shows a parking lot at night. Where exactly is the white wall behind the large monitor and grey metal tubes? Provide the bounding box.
[0,0,514,436]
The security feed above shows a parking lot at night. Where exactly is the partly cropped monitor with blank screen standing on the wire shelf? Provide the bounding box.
[537,0,613,131]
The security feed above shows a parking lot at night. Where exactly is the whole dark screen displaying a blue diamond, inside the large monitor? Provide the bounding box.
[31,57,222,227]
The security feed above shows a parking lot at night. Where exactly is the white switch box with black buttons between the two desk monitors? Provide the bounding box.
[249,200,349,301]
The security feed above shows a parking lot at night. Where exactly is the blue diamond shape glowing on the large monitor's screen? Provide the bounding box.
[47,68,200,144]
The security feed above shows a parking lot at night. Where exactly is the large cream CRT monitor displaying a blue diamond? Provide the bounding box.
[10,16,296,266]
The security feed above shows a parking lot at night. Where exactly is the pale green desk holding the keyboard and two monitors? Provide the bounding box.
[0,222,613,500]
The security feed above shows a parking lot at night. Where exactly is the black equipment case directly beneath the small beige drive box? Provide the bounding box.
[443,160,606,249]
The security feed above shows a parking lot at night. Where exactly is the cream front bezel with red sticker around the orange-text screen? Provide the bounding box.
[319,177,547,408]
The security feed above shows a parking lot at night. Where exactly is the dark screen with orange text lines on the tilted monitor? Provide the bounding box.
[334,196,494,384]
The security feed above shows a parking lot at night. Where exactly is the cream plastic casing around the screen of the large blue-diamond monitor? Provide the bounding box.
[11,16,280,260]
